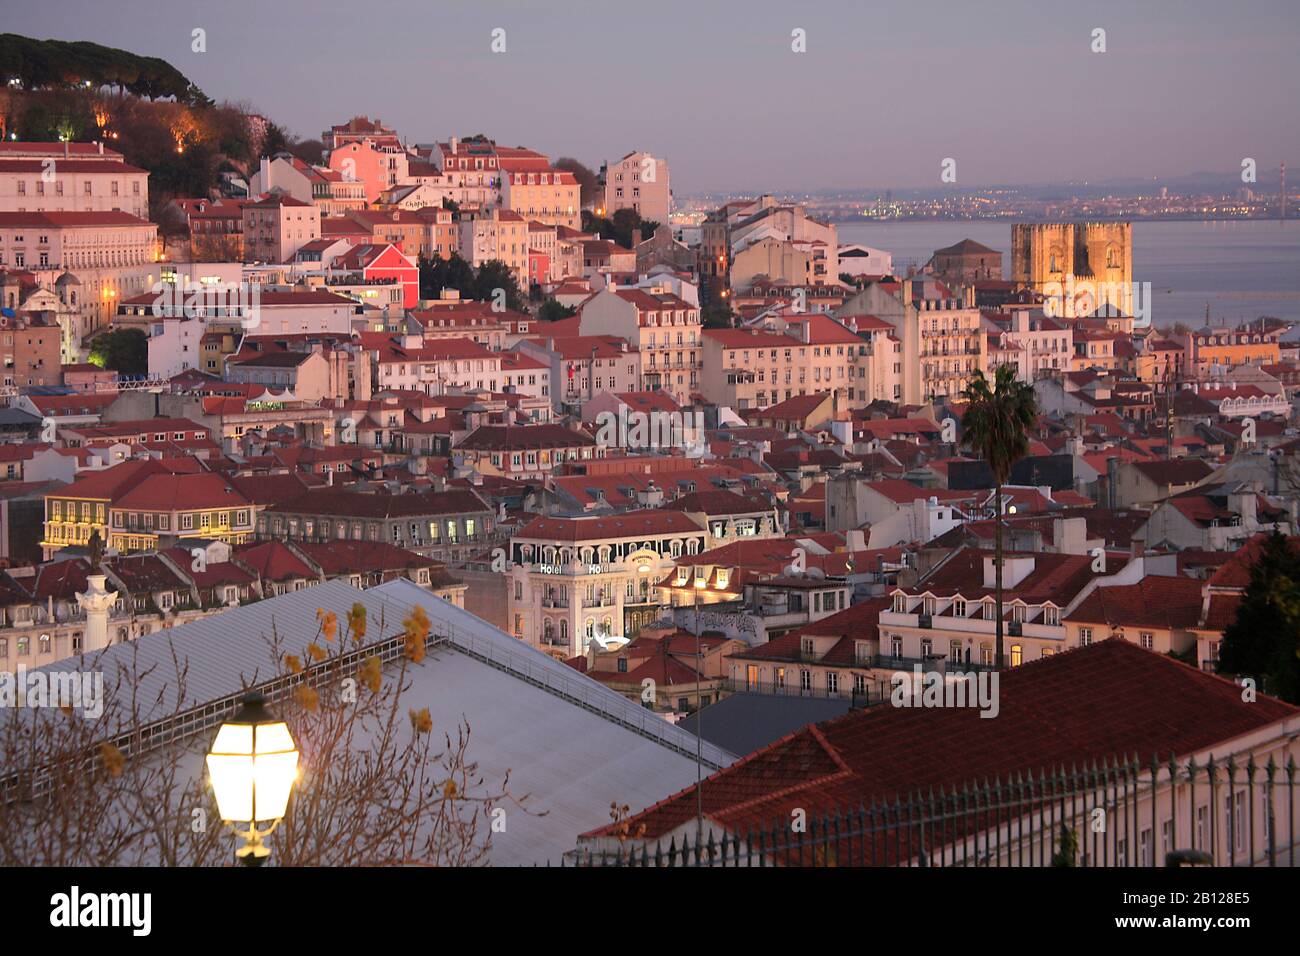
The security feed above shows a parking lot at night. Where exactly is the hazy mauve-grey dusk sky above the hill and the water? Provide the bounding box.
[10,0,1300,195]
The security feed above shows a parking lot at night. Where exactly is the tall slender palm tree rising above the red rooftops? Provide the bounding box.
[962,365,1039,670]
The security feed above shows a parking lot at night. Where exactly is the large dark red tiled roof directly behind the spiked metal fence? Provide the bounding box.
[589,640,1300,839]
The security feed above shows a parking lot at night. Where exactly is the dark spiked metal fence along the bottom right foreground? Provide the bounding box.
[564,749,1297,868]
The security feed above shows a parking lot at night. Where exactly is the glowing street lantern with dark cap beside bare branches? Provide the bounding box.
[208,693,298,866]
